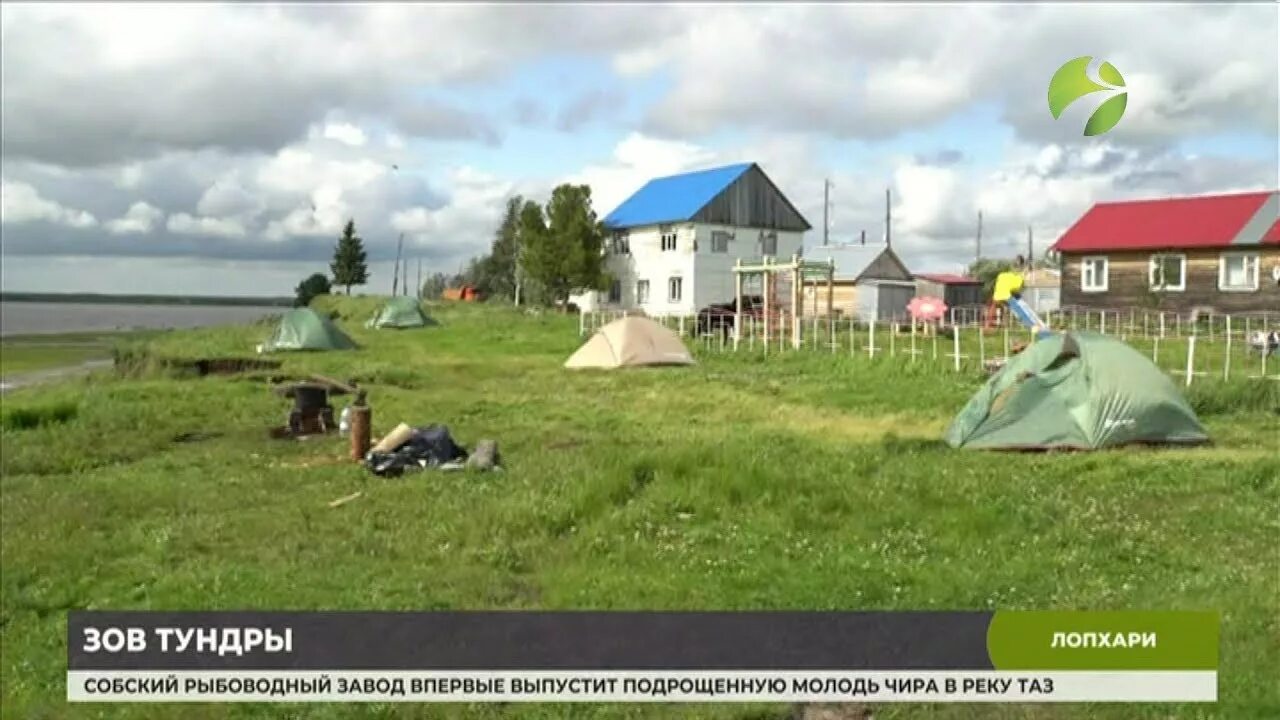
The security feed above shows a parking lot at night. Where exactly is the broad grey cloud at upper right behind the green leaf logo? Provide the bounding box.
[634,5,1280,145]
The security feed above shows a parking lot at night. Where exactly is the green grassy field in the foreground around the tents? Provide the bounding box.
[0,294,1280,720]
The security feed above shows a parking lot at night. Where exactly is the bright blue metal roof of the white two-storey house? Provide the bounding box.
[604,163,754,228]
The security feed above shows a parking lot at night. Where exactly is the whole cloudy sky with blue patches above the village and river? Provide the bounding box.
[0,3,1280,296]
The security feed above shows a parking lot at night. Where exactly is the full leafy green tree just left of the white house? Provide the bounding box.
[517,184,607,305]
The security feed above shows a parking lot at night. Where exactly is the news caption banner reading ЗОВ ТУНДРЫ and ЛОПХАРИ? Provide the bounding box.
[67,611,1219,702]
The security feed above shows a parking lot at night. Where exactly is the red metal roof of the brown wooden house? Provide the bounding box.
[1053,191,1280,252]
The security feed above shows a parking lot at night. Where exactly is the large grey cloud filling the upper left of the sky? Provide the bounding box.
[0,4,660,167]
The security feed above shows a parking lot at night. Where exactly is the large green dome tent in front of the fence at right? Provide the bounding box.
[945,332,1208,450]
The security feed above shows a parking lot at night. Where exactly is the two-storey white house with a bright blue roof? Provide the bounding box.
[571,163,812,315]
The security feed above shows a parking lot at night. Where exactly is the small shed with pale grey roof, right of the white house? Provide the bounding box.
[804,245,915,322]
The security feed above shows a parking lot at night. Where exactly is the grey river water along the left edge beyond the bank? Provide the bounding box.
[0,301,288,337]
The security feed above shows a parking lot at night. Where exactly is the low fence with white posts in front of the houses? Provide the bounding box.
[579,306,1280,386]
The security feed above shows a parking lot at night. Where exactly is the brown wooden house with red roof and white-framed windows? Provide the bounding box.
[1052,191,1280,314]
